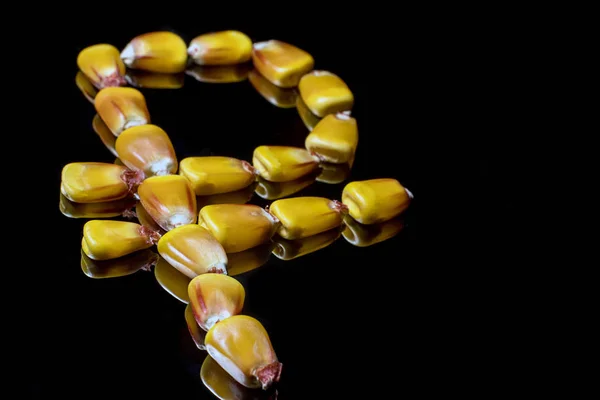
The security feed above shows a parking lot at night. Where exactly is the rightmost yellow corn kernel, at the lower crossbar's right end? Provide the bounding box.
[342,178,413,225]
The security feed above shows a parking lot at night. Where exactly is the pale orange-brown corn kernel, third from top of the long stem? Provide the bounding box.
[115,124,177,177]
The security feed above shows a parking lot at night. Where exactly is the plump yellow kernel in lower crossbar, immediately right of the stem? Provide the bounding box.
[198,204,277,253]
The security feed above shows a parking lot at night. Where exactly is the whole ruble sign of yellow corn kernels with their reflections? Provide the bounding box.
[60,31,412,397]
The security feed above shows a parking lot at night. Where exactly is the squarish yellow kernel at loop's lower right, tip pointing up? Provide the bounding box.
[304,112,358,164]
